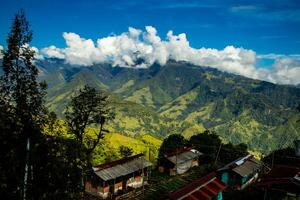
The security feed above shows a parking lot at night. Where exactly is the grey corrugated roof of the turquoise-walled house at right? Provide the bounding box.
[232,158,261,177]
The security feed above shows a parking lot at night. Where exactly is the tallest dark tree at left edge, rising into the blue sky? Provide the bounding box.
[0,10,46,199]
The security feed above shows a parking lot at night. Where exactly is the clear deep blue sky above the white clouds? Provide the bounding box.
[0,0,300,54]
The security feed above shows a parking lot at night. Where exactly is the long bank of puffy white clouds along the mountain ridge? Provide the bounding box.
[41,26,300,84]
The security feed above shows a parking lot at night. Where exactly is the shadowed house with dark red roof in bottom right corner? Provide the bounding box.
[255,165,300,198]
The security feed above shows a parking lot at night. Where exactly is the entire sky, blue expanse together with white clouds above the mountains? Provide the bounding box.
[0,0,300,84]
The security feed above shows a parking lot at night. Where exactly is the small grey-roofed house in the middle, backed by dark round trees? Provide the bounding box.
[158,148,202,176]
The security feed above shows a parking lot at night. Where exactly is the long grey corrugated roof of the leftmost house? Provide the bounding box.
[95,158,152,181]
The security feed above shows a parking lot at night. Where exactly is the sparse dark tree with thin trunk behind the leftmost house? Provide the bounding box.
[65,85,113,168]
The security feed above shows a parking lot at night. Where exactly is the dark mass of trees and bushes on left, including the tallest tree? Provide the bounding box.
[0,10,80,199]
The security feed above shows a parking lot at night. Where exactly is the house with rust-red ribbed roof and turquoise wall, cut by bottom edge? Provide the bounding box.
[169,172,226,200]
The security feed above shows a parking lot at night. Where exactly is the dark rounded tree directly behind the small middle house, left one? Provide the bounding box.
[158,134,187,158]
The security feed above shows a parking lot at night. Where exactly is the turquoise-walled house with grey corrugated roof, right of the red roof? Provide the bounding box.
[217,155,263,190]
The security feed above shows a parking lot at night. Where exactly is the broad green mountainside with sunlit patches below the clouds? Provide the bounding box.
[36,59,300,153]
